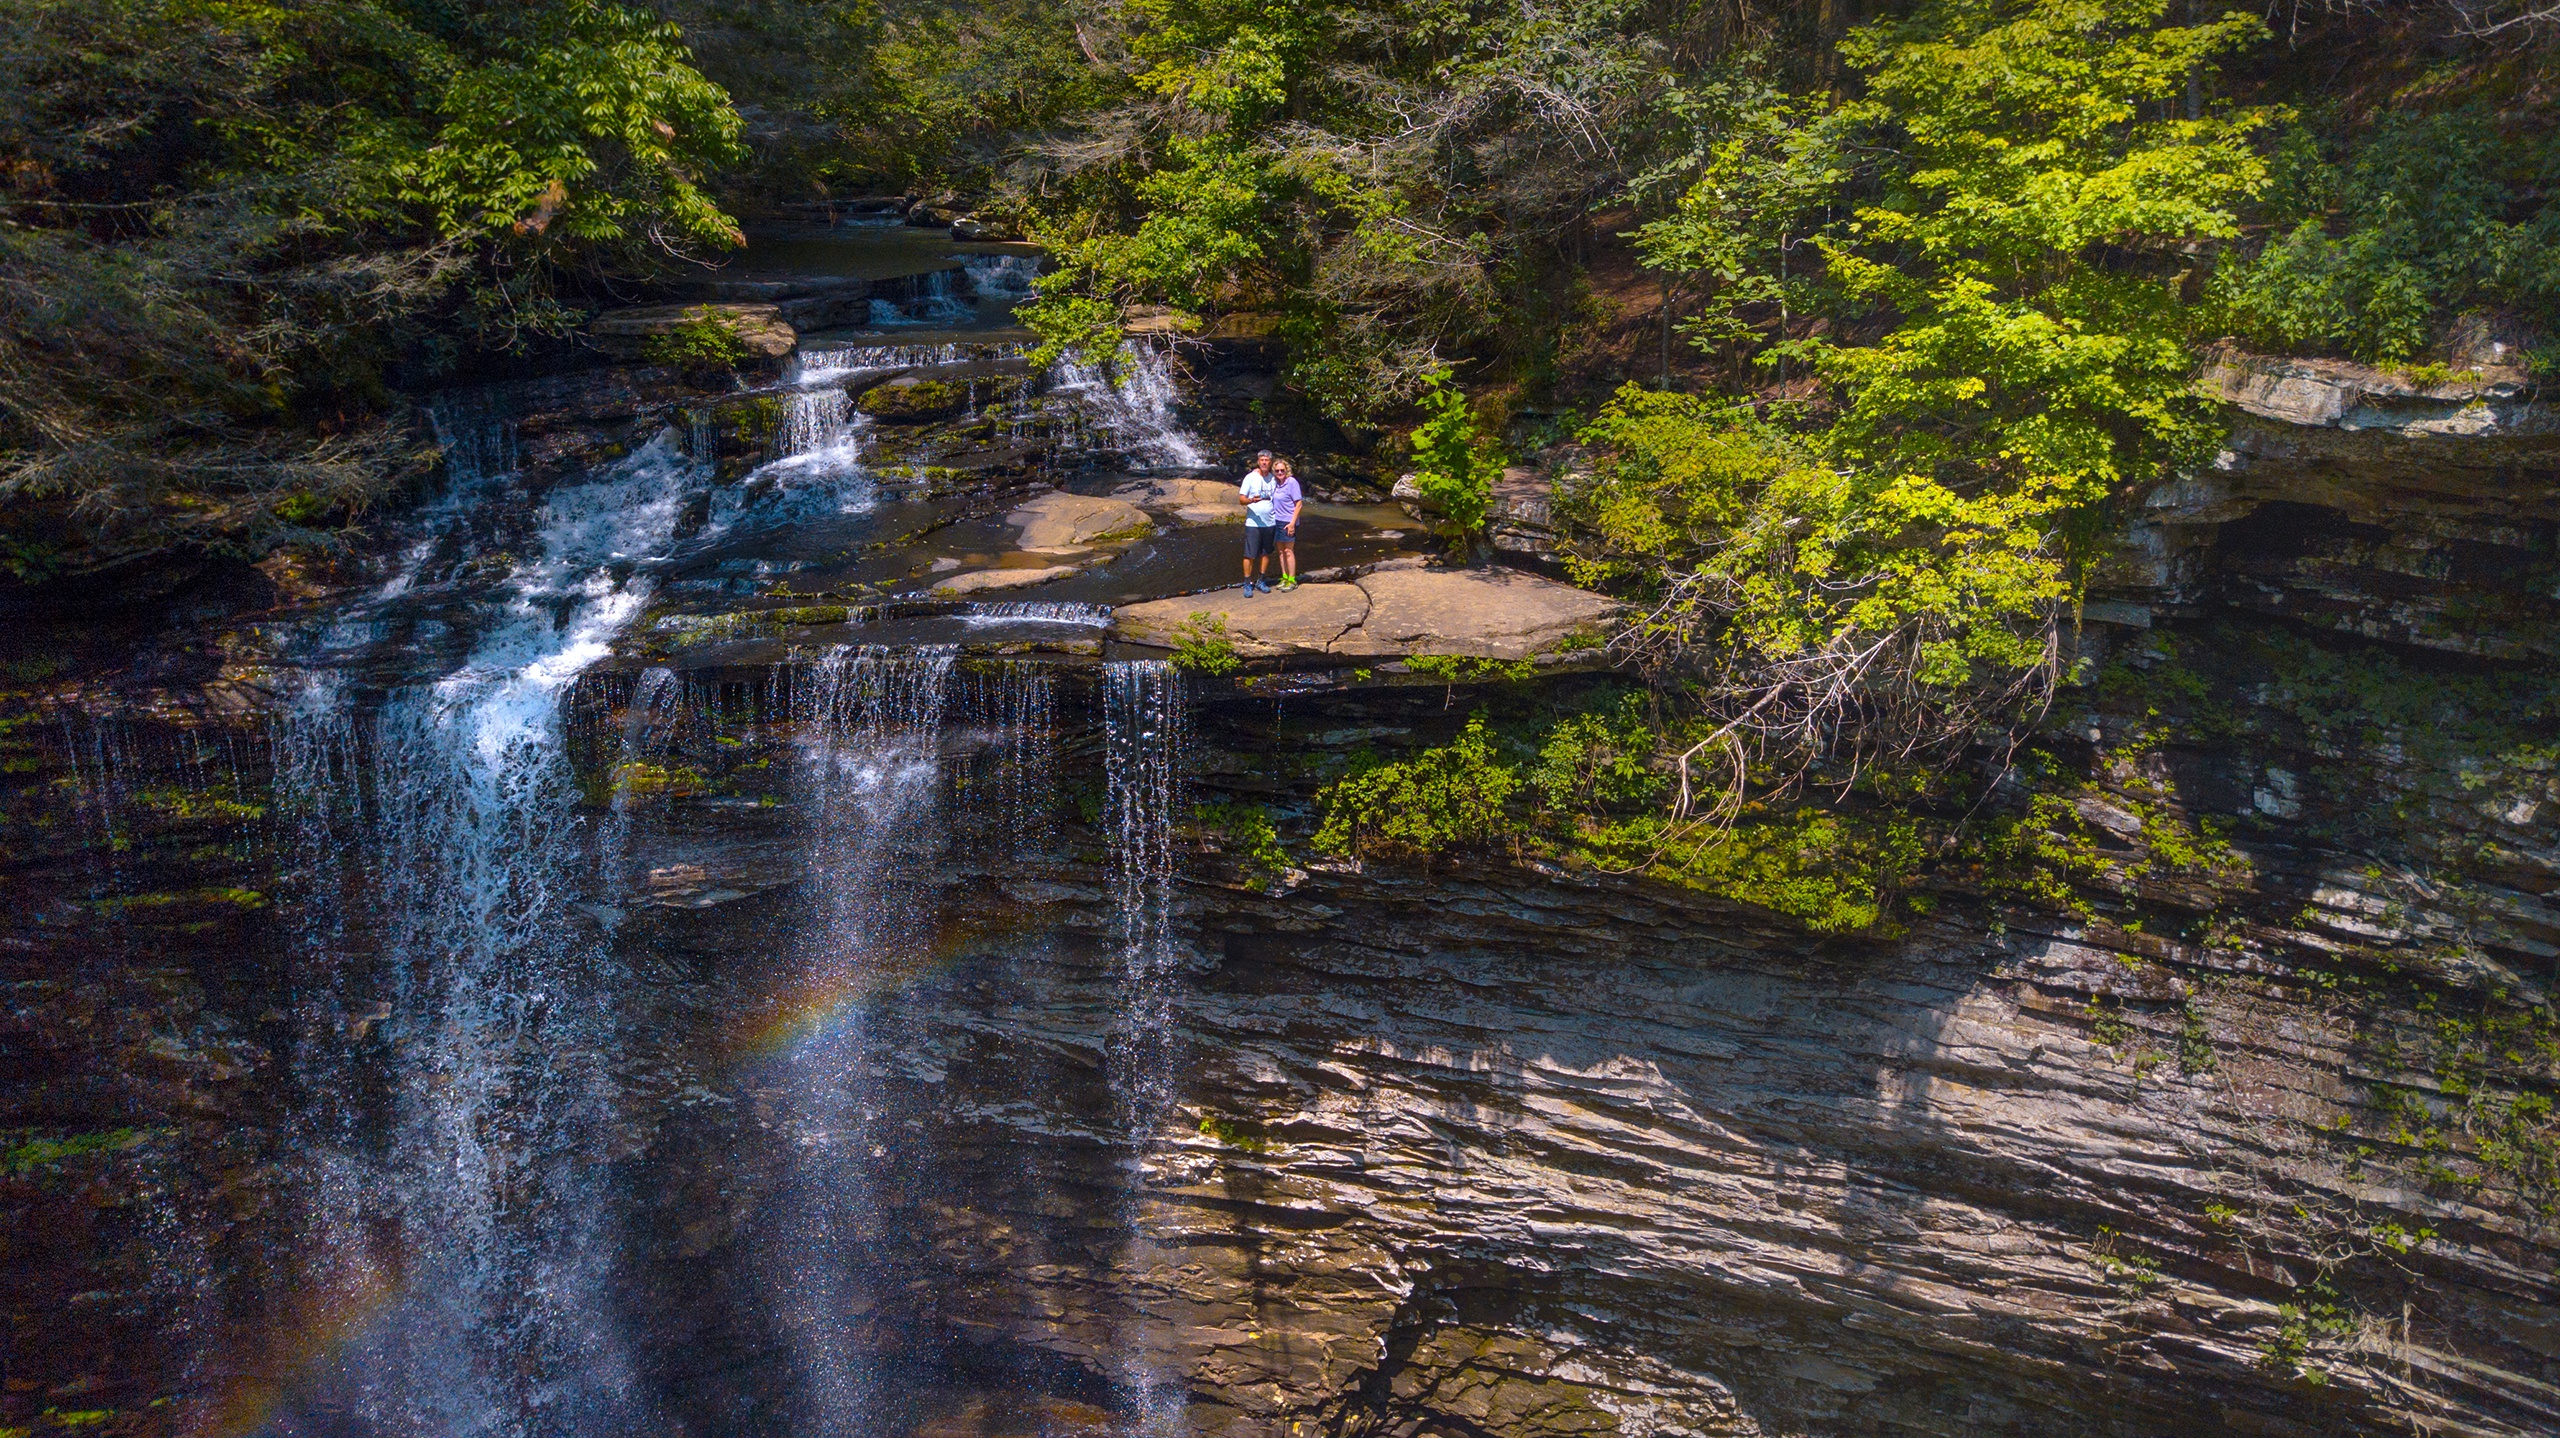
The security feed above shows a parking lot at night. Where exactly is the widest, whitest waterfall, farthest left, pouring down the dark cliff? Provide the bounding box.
[276,432,701,1435]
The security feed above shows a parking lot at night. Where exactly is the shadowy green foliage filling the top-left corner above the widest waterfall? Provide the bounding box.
[0,0,740,578]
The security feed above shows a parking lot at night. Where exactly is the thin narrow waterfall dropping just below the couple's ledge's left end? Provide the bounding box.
[1103,660,1185,1438]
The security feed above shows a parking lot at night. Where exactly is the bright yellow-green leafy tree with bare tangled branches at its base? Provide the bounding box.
[1567,0,2266,819]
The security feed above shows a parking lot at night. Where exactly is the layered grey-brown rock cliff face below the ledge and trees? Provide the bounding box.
[0,350,2560,1438]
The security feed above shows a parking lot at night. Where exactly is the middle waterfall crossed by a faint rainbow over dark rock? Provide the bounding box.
[765,647,957,1438]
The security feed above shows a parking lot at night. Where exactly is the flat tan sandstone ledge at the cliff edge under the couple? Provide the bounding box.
[1111,568,1618,660]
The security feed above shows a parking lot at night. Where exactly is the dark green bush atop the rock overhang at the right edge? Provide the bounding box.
[2214,105,2560,363]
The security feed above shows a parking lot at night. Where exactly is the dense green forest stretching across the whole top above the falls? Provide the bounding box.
[0,0,2560,900]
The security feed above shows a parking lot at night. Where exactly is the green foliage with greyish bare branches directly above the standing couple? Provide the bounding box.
[1009,0,1725,425]
